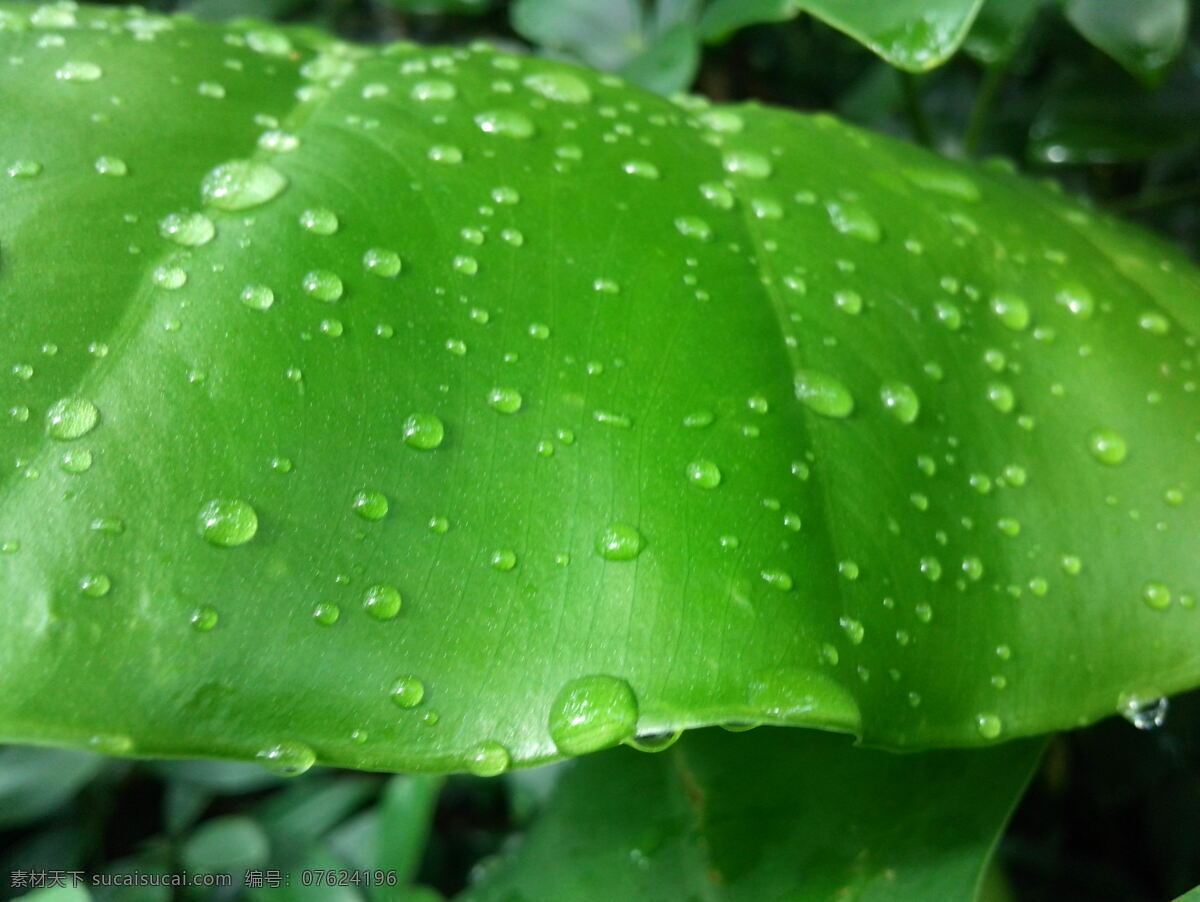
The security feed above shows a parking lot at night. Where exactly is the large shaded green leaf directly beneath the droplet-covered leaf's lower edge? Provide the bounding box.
[462,729,1043,902]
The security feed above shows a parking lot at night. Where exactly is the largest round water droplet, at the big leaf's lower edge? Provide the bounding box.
[548,674,638,754]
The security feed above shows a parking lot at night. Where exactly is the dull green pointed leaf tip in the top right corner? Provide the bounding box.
[1063,0,1188,85]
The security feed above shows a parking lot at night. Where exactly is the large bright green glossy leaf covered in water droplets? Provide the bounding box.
[0,6,1200,774]
